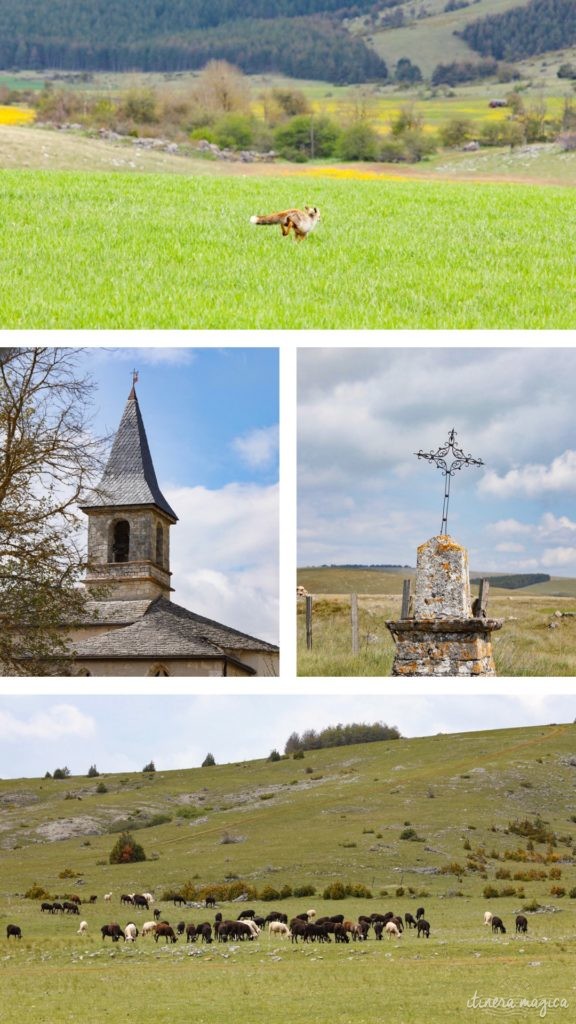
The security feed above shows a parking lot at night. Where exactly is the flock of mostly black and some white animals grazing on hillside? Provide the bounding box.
[2,893,528,945]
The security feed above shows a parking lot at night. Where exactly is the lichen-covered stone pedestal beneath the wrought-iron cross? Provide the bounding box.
[386,534,502,676]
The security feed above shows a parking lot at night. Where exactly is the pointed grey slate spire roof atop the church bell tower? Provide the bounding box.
[82,384,178,522]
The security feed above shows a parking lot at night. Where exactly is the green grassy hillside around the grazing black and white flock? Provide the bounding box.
[0,723,576,1024]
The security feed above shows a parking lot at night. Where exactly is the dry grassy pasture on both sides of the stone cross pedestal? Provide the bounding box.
[297,568,576,676]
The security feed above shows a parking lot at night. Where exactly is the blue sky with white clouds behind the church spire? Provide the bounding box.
[72,346,278,642]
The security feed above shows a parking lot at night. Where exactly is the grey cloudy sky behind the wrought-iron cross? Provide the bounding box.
[298,347,576,577]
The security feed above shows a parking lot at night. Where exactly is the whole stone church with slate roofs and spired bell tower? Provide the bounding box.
[69,386,279,676]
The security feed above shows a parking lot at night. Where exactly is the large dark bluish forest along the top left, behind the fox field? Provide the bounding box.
[0,0,387,84]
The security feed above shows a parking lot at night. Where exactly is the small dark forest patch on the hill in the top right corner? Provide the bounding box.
[458,0,576,60]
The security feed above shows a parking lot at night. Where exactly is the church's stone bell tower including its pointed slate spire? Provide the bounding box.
[82,373,177,601]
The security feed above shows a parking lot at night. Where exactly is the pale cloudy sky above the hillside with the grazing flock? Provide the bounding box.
[0,693,575,778]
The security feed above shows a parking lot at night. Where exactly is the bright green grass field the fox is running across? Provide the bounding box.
[0,171,576,330]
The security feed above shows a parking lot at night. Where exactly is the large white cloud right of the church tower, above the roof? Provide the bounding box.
[164,483,278,642]
